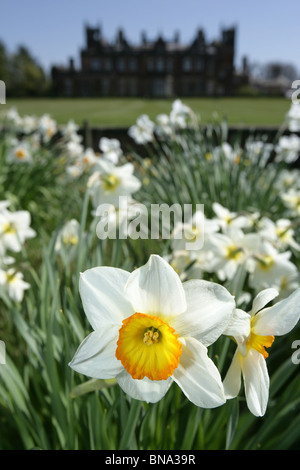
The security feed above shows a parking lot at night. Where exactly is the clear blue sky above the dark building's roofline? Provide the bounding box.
[0,0,300,74]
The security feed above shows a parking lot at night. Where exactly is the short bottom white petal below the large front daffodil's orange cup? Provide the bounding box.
[116,370,173,403]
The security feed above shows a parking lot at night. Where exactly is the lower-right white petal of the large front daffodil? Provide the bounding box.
[172,338,226,408]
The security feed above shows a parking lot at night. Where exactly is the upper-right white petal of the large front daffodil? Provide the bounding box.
[170,279,235,346]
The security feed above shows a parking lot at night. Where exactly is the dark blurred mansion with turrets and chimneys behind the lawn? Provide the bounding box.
[52,27,239,98]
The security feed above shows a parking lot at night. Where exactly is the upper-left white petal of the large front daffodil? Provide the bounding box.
[79,266,134,330]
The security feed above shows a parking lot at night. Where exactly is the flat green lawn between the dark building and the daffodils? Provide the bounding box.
[2,98,291,127]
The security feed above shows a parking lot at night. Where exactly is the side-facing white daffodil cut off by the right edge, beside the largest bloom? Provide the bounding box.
[223,288,300,416]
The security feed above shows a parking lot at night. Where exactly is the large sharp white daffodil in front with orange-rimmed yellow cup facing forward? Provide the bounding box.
[69,255,235,408]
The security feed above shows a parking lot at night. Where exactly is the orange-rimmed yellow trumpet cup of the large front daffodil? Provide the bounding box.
[116,312,182,380]
